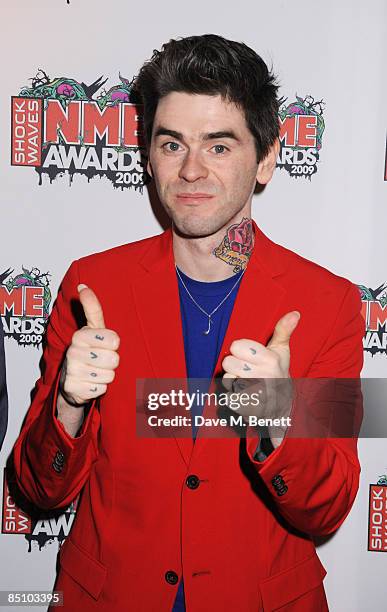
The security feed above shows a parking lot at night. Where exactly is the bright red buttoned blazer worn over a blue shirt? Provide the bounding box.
[14,226,364,612]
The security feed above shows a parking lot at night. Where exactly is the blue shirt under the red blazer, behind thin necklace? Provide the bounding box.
[172,269,242,612]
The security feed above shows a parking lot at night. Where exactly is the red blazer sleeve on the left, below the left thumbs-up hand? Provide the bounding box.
[13,262,100,509]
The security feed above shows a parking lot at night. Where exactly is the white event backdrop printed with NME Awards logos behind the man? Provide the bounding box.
[0,0,387,612]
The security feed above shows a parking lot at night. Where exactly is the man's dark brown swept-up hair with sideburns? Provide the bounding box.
[134,34,281,161]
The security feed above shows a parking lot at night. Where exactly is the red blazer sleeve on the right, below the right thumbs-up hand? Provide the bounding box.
[246,283,365,536]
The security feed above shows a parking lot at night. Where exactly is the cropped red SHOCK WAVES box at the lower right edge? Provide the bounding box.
[368,486,387,552]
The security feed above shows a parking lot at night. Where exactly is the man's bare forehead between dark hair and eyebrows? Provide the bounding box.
[154,91,249,136]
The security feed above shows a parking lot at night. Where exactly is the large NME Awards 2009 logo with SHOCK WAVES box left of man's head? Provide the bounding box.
[11,70,149,192]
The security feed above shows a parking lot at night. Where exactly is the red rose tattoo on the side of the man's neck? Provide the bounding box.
[212,217,254,274]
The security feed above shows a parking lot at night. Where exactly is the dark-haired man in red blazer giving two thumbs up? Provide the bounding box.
[14,35,363,612]
